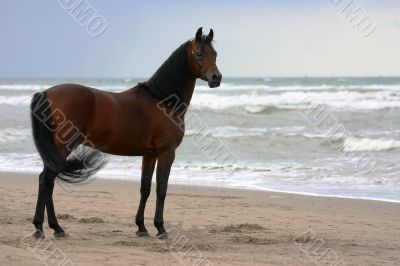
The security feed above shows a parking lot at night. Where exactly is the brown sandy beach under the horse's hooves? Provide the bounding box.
[0,170,400,265]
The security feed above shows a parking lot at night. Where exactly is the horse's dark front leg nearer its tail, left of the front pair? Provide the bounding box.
[136,156,157,236]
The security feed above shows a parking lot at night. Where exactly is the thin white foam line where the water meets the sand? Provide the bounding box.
[0,169,400,204]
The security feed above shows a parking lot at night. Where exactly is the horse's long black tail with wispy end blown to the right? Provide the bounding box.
[31,92,105,183]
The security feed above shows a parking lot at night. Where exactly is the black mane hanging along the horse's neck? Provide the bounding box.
[142,41,190,102]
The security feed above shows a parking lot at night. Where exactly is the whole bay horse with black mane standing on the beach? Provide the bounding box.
[31,28,222,239]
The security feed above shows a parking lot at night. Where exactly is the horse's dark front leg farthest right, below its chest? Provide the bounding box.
[154,150,175,239]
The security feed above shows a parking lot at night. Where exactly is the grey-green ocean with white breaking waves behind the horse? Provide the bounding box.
[0,77,400,202]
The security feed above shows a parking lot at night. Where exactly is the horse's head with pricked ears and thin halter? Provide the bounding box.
[190,28,222,88]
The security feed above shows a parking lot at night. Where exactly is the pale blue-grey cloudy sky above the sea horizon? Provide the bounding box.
[0,0,400,78]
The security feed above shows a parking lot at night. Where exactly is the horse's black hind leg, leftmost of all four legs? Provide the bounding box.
[33,167,57,238]
